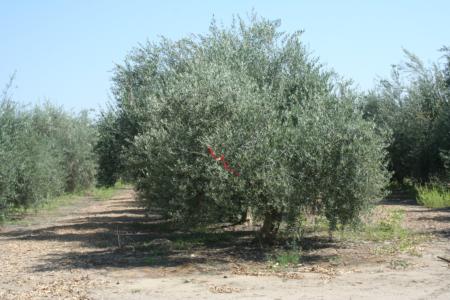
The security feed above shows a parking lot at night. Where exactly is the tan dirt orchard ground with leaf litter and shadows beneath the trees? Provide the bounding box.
[0,189,450,300]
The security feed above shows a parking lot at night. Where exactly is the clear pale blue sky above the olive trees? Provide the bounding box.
[0,0,450,111]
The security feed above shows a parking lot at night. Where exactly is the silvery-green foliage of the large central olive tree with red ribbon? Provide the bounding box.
[106,16,388,241]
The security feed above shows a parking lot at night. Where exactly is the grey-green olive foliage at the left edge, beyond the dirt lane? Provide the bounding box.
[0,79,96,220]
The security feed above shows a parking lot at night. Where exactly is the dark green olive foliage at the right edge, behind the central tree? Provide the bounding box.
[363,48,450,182]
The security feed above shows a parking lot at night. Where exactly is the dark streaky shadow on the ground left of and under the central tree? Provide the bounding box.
[0,197,337,272]
